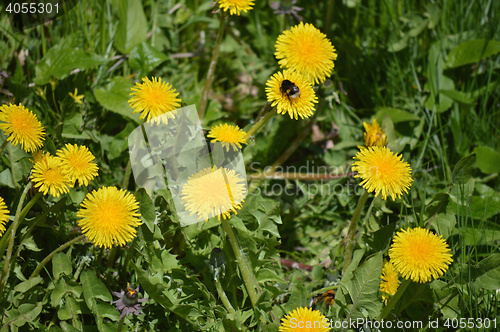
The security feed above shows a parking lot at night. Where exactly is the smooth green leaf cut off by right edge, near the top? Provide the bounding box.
[446,39,500,68]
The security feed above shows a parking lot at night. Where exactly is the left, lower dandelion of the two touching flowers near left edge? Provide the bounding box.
[31,156,71,197]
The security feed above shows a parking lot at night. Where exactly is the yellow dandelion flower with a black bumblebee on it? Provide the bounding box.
[266,70,318,120]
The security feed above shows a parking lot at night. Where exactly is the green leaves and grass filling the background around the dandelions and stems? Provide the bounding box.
[0,0,500,332]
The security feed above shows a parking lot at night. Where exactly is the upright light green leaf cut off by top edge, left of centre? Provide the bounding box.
[115,0,148,54]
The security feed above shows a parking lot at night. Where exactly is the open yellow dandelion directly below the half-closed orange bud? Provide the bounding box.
[352,146,413,200]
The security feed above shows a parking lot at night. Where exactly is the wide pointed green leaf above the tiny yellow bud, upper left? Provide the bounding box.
[34,38,108,85]
